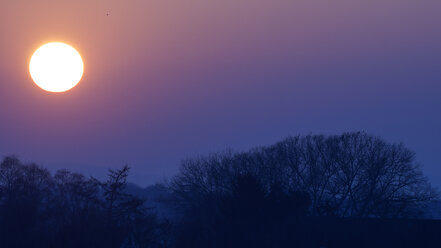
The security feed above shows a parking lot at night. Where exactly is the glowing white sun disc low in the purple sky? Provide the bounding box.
[29,42,84,92]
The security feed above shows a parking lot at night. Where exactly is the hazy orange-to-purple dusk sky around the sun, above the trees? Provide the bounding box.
[0,0,441,186]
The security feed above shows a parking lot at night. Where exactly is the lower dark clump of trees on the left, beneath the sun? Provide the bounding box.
[0,157,170,248]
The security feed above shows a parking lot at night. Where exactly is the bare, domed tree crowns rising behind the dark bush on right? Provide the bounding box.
[170,132,437,217]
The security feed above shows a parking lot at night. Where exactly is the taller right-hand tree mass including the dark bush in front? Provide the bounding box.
[169,133,441,247]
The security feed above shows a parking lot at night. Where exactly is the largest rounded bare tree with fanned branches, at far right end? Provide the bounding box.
[275,133,437,217]
